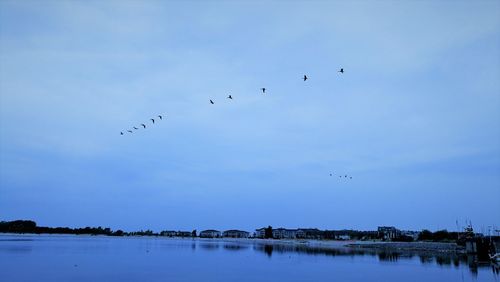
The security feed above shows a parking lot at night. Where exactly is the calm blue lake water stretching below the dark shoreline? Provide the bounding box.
[0,234,500,282]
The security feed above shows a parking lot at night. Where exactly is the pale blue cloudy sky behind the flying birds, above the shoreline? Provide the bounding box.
[0,1,500,234]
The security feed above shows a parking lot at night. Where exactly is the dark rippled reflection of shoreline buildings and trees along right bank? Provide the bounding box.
[253,242,500,275]
